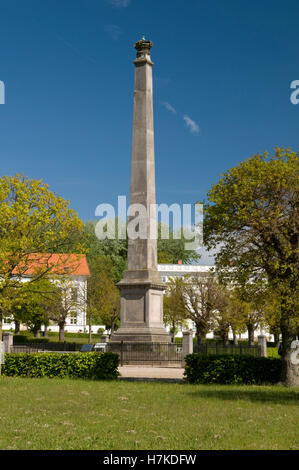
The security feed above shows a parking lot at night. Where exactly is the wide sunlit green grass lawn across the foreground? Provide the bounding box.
[0,377,299,450]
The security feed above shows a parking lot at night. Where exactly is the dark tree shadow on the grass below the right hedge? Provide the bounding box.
[189,385,299,405]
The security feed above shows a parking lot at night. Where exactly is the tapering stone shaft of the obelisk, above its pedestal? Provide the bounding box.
[128,41,157,278]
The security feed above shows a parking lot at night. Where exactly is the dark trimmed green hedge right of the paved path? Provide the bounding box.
[184,354,282,384]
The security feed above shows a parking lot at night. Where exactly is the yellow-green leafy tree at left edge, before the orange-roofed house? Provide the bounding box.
[0,174,82,346]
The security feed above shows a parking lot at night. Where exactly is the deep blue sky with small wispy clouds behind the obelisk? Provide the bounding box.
[0,0,299,229]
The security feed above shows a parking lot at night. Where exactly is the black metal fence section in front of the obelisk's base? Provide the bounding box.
[107,342,183,365]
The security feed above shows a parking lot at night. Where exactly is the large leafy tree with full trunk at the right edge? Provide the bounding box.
[204,148,299,386]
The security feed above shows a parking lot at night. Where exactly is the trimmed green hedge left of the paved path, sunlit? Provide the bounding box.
[2,352,119,380]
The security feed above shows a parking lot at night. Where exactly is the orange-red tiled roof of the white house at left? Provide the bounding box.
[13,253,90,276]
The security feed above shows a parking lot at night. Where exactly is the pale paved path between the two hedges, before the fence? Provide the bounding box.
[118,366,184,382]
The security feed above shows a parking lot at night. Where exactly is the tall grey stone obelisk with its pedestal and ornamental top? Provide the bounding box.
[111,38,170,342]
